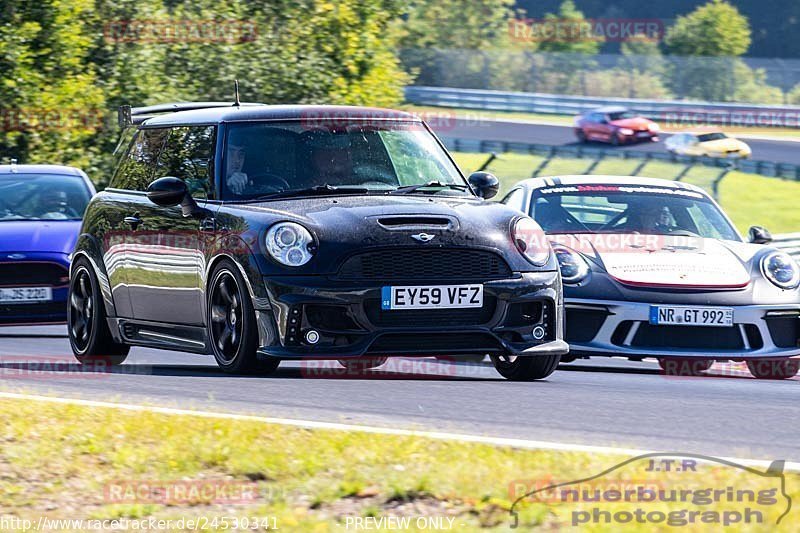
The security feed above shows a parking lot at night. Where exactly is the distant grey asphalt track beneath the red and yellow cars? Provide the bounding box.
[433,118,800,165]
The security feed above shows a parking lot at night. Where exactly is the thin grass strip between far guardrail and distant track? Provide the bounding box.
[401,104,800,140]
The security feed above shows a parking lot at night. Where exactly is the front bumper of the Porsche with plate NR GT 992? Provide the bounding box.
[565,298,800,360]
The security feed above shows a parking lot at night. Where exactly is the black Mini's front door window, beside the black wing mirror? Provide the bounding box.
[155,126,216,199]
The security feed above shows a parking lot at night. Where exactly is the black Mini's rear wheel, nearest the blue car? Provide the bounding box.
[67,257,130,366]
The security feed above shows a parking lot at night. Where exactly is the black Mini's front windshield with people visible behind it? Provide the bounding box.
[223,121,470,200]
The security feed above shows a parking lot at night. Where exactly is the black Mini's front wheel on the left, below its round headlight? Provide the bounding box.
[206,259,280,374]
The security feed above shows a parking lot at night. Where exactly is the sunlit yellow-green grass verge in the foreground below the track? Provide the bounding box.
[0,396,800,531]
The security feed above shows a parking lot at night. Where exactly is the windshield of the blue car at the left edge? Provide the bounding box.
[0,174,91,222]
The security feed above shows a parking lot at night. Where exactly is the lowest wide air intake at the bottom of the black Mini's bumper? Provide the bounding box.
[369,333,503,355]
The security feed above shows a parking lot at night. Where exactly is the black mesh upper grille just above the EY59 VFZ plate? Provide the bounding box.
[339,248,511,281]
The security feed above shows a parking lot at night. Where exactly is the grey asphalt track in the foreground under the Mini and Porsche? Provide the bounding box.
[0,326,800,462]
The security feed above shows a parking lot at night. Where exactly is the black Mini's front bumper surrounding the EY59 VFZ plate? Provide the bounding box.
[256,272,568,359]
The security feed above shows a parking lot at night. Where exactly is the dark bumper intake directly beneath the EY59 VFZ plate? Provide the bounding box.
[364,294,497,328]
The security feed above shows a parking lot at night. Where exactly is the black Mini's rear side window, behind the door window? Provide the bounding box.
[111,128,169,191]
